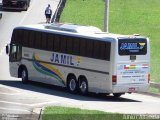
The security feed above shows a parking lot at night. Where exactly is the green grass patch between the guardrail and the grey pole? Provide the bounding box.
[60,0,104,28]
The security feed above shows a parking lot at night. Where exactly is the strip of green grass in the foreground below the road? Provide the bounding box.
[42,106,123,120]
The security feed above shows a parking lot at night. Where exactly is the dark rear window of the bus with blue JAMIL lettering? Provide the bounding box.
[118,38,147,55]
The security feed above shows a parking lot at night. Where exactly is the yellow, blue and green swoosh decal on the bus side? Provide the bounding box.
[33,54,65,85]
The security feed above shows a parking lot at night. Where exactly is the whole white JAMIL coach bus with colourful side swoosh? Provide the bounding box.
[6,23,150,97]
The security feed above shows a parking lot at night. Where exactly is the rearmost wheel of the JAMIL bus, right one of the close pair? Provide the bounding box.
[79,78,88,95]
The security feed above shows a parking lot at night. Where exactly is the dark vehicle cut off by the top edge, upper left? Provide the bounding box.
[2,0,30,11]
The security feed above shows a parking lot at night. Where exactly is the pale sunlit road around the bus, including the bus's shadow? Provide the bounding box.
[0,0,160,117]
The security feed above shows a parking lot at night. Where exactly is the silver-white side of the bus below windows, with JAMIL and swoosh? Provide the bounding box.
[22,48,111,93]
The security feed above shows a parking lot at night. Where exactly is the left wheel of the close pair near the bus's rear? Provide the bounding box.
[67,76,78,93]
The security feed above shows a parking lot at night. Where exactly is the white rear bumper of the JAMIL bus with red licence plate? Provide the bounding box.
[112,83,150,93]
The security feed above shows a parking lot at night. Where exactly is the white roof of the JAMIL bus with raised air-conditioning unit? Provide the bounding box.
[15,23,146,40]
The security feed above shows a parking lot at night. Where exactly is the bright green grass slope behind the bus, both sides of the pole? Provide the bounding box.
[60,0,160,82]
